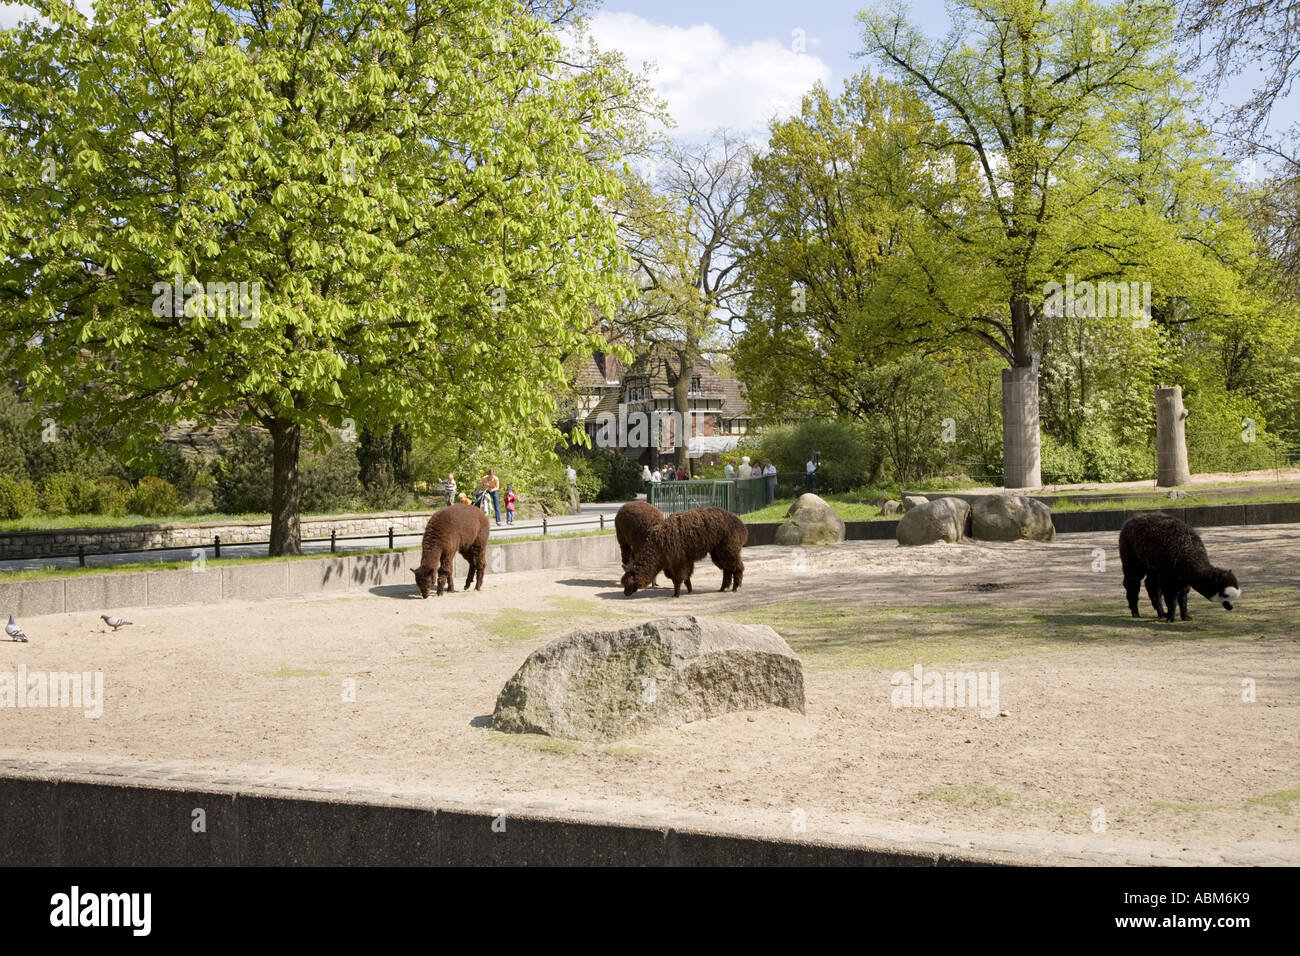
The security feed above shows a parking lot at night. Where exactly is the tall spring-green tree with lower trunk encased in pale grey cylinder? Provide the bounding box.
[859,0,1222,485]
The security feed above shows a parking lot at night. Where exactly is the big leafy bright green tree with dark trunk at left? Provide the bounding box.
[0,0,623,554]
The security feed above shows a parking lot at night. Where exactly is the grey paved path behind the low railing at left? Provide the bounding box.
[0,502,623,574]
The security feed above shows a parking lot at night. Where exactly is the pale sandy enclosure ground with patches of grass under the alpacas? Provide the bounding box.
[0,525,1300,862]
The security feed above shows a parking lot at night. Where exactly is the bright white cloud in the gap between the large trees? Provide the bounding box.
[592,13,831,139]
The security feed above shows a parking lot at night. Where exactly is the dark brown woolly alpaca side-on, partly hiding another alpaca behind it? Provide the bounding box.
[623,507,749,597]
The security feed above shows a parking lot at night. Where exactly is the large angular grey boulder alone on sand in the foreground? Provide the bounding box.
[491,617,803,740]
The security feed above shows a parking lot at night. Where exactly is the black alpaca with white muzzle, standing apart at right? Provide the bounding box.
[1119,511,1242,622]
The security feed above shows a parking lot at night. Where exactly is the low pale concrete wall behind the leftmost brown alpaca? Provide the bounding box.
[0,535,619,619]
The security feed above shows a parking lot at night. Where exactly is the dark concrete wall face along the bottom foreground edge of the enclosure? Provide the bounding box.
[0,777,982,866]
